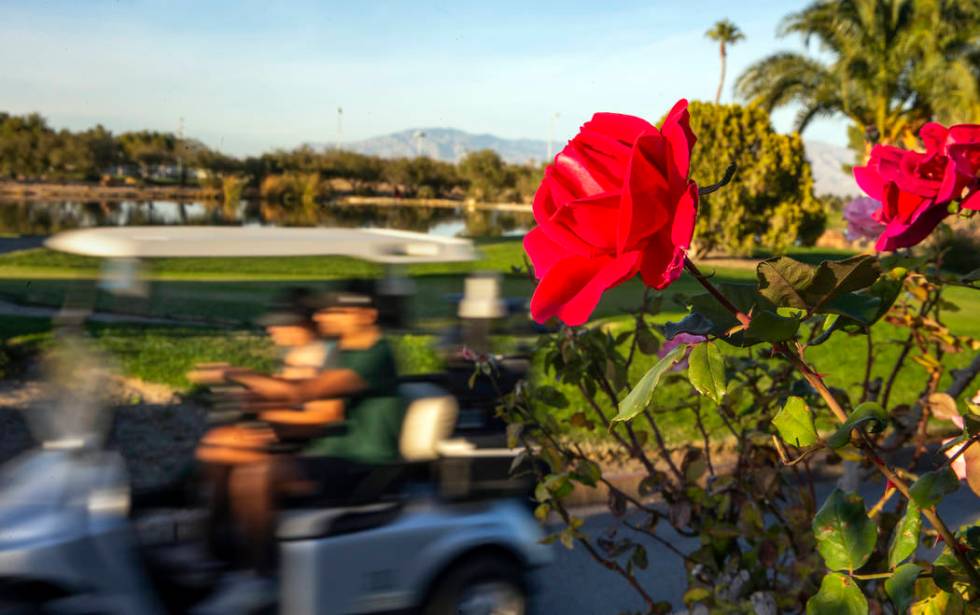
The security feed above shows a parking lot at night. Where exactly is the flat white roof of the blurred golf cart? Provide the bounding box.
[44,226,476,264]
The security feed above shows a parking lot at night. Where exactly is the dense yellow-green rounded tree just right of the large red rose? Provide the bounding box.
[668,101,825,254]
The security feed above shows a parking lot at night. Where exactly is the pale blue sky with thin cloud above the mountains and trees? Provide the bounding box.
[0,0,845,154]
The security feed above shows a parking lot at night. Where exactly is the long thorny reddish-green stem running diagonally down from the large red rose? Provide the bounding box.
[684,257,980,587]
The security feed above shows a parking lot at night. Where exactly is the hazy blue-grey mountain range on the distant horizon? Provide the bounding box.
[314,128,858,196]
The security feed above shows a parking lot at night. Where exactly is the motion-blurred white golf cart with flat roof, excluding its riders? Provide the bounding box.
[0,227,550,615]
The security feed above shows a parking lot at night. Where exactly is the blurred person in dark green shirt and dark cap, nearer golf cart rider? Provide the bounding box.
[191,283,405,612]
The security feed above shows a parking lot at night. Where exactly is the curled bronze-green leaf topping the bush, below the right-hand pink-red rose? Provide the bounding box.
[756,255,882,322]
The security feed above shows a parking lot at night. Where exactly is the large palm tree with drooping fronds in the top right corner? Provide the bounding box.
[736,0,980,151]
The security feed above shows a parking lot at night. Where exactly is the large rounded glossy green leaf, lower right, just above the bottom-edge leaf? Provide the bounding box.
[812,489,878,572]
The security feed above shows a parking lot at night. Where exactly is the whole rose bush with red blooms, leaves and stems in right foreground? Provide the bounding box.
[506,108,980,615]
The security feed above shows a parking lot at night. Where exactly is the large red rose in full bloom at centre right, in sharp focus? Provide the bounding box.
[524,100,698,325]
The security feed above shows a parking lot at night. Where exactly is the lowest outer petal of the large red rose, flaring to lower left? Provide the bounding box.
[531,252,639,326]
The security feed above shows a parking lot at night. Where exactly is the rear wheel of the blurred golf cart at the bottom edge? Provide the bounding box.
[422,556,528,615]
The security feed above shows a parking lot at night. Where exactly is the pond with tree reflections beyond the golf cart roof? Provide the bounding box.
[0,201,533,237]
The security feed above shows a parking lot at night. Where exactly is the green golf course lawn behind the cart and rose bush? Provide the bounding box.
[0,239,980,443]
